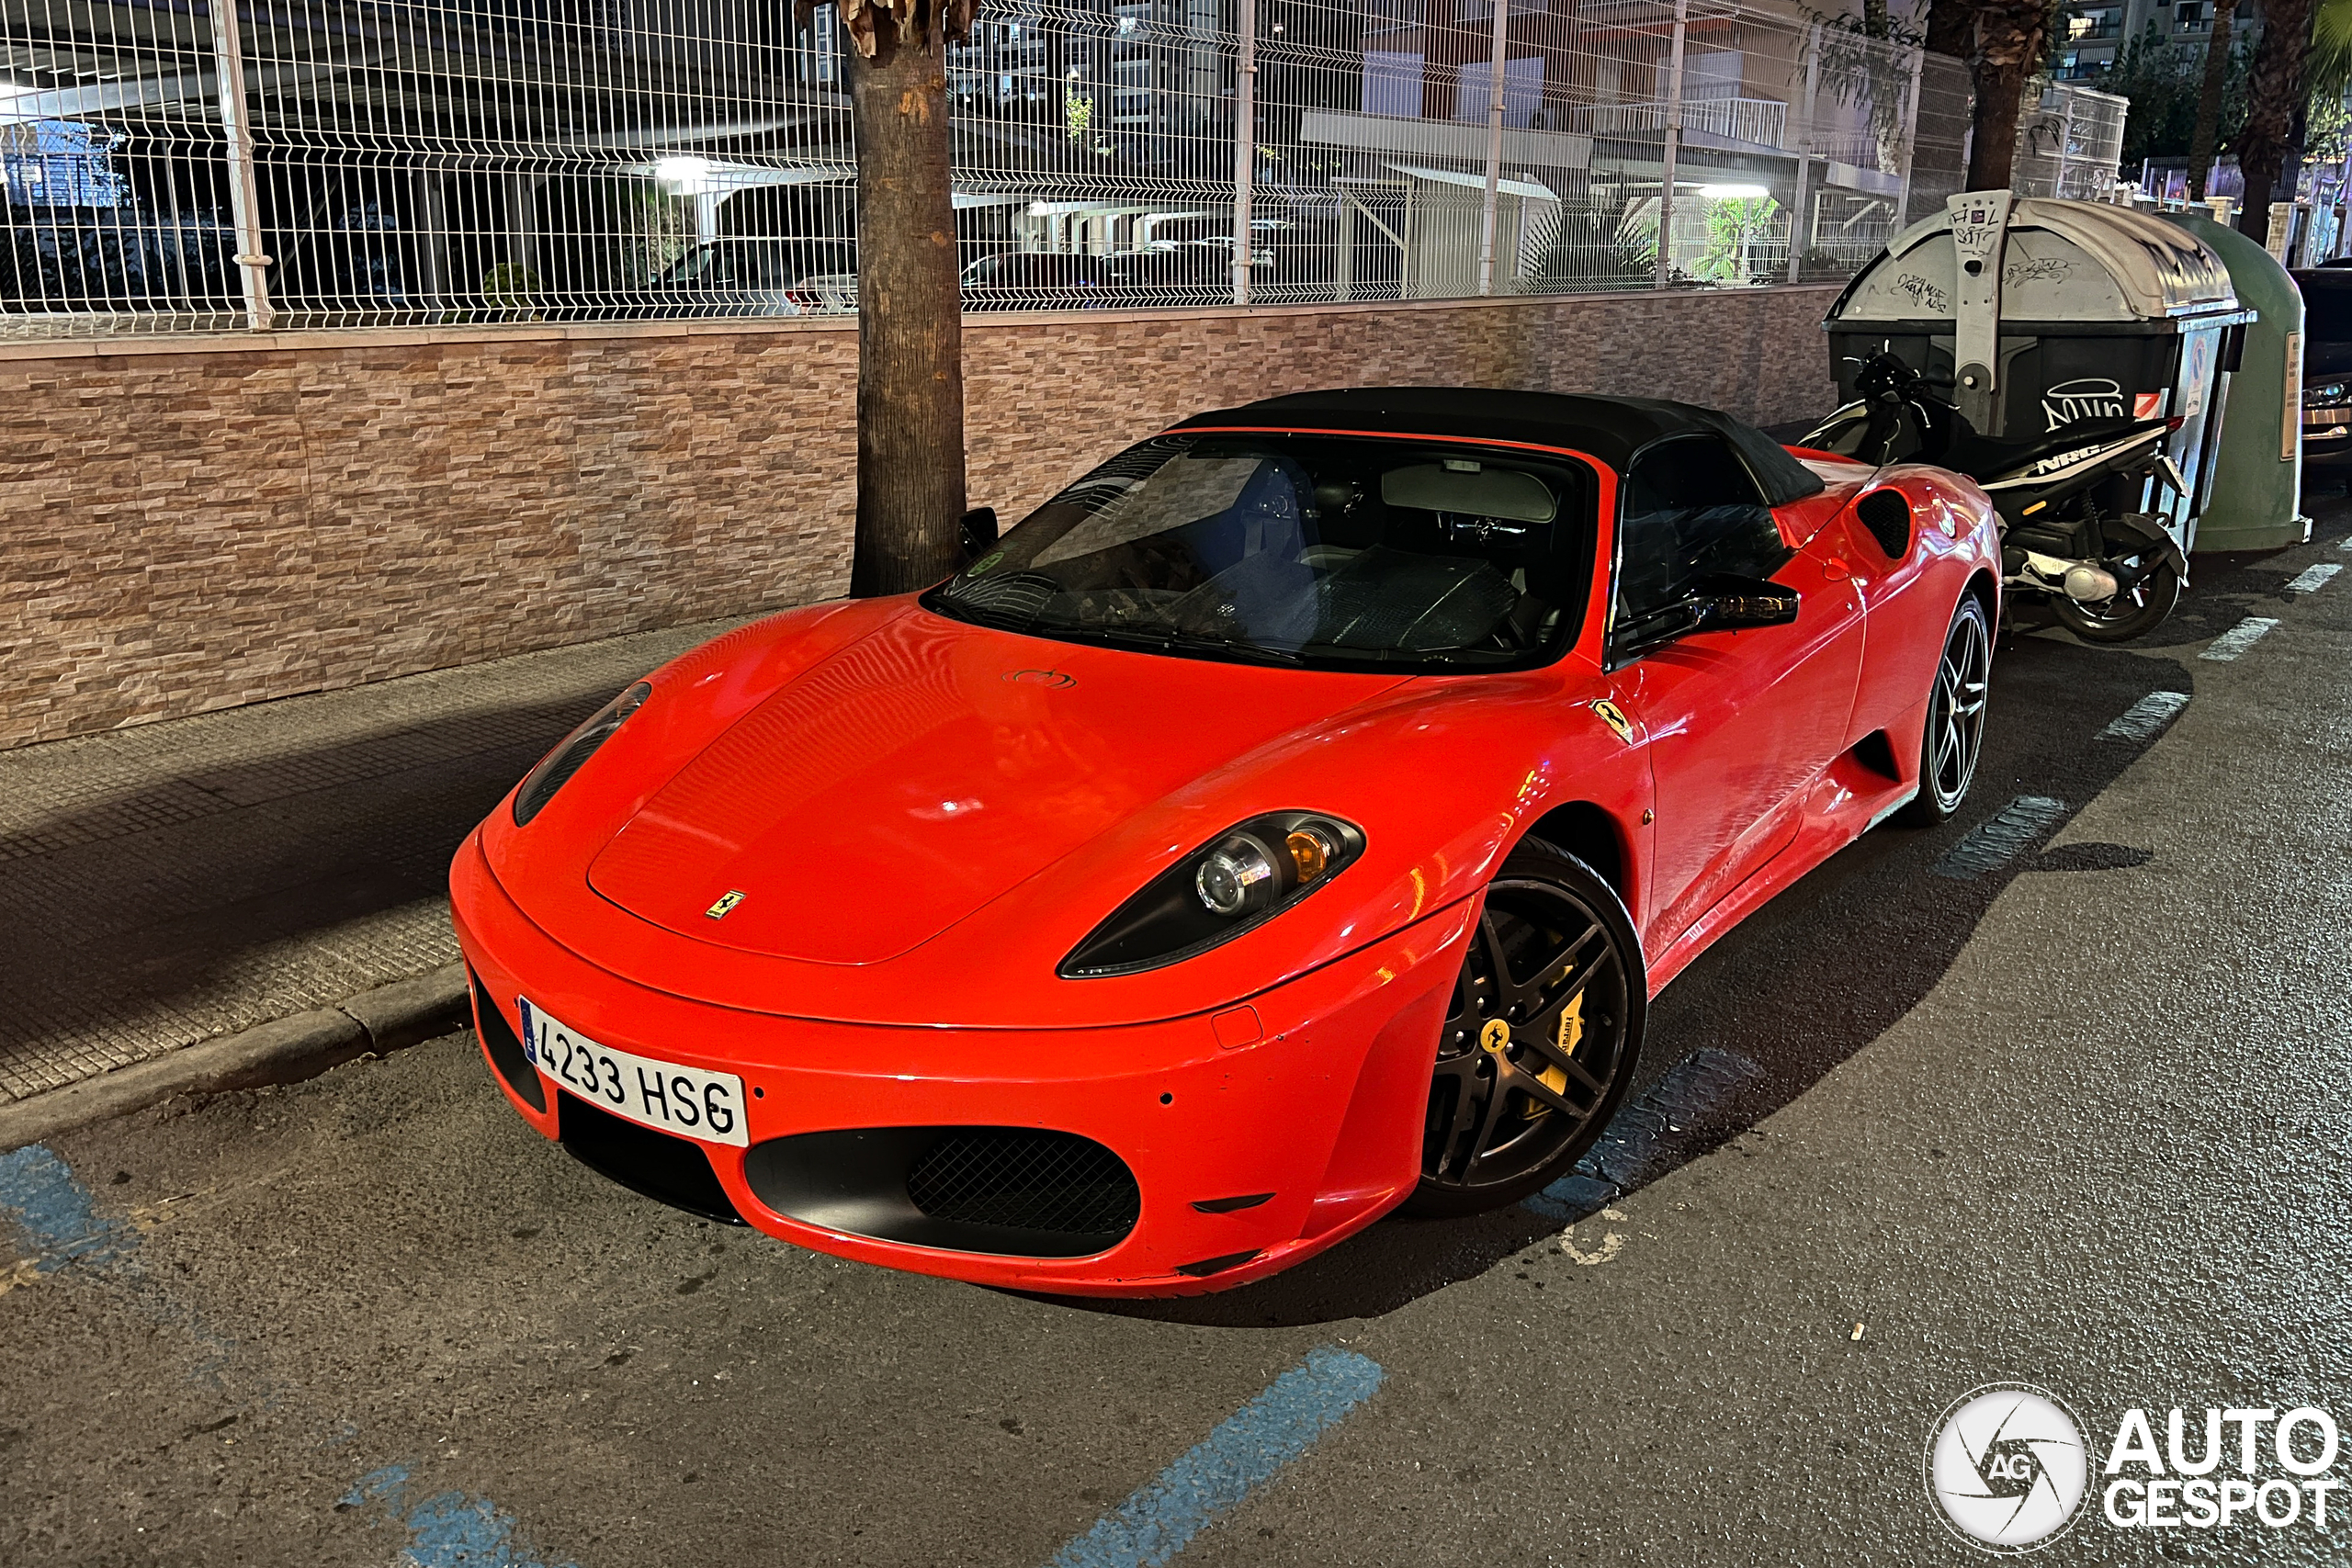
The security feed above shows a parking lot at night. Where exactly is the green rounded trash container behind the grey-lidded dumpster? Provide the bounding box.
[2164,211,2312,555]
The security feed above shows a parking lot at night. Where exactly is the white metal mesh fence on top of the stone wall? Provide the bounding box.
[0,0,1966,336]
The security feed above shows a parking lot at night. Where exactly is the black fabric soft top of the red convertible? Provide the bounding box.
[1176,386,1823,505]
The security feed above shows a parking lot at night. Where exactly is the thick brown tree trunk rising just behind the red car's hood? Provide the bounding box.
[842,0,969,597]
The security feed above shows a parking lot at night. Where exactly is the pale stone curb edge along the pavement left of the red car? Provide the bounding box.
[0,964,470,1152]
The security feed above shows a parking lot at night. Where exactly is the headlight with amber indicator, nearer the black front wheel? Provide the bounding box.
[1058,811,1364,980]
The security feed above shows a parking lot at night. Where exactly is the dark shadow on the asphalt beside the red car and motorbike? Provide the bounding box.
[1051,499,2352,1328]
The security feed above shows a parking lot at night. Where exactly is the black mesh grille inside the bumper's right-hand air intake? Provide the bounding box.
[906,1126,1143,1236]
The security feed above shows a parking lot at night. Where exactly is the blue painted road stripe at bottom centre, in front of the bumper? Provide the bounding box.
[1049,1345,1387,1568]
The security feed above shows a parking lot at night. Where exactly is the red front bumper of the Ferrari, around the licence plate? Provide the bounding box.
[449,840,1475,1295]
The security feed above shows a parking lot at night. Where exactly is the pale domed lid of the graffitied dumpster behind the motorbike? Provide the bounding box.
[1832,197,2237,322]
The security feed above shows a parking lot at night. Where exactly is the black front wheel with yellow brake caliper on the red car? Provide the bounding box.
[1407,840,1649,1215]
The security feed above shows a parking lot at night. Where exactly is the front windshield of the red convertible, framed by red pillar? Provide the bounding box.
[924,433,1595,668]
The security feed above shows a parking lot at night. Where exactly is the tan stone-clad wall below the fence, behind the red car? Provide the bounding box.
[0,287,1835,748]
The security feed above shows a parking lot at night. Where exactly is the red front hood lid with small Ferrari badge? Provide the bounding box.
[588,606,1402,964]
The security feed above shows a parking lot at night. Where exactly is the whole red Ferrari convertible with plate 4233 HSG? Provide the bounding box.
[452,388,1999,1295]
